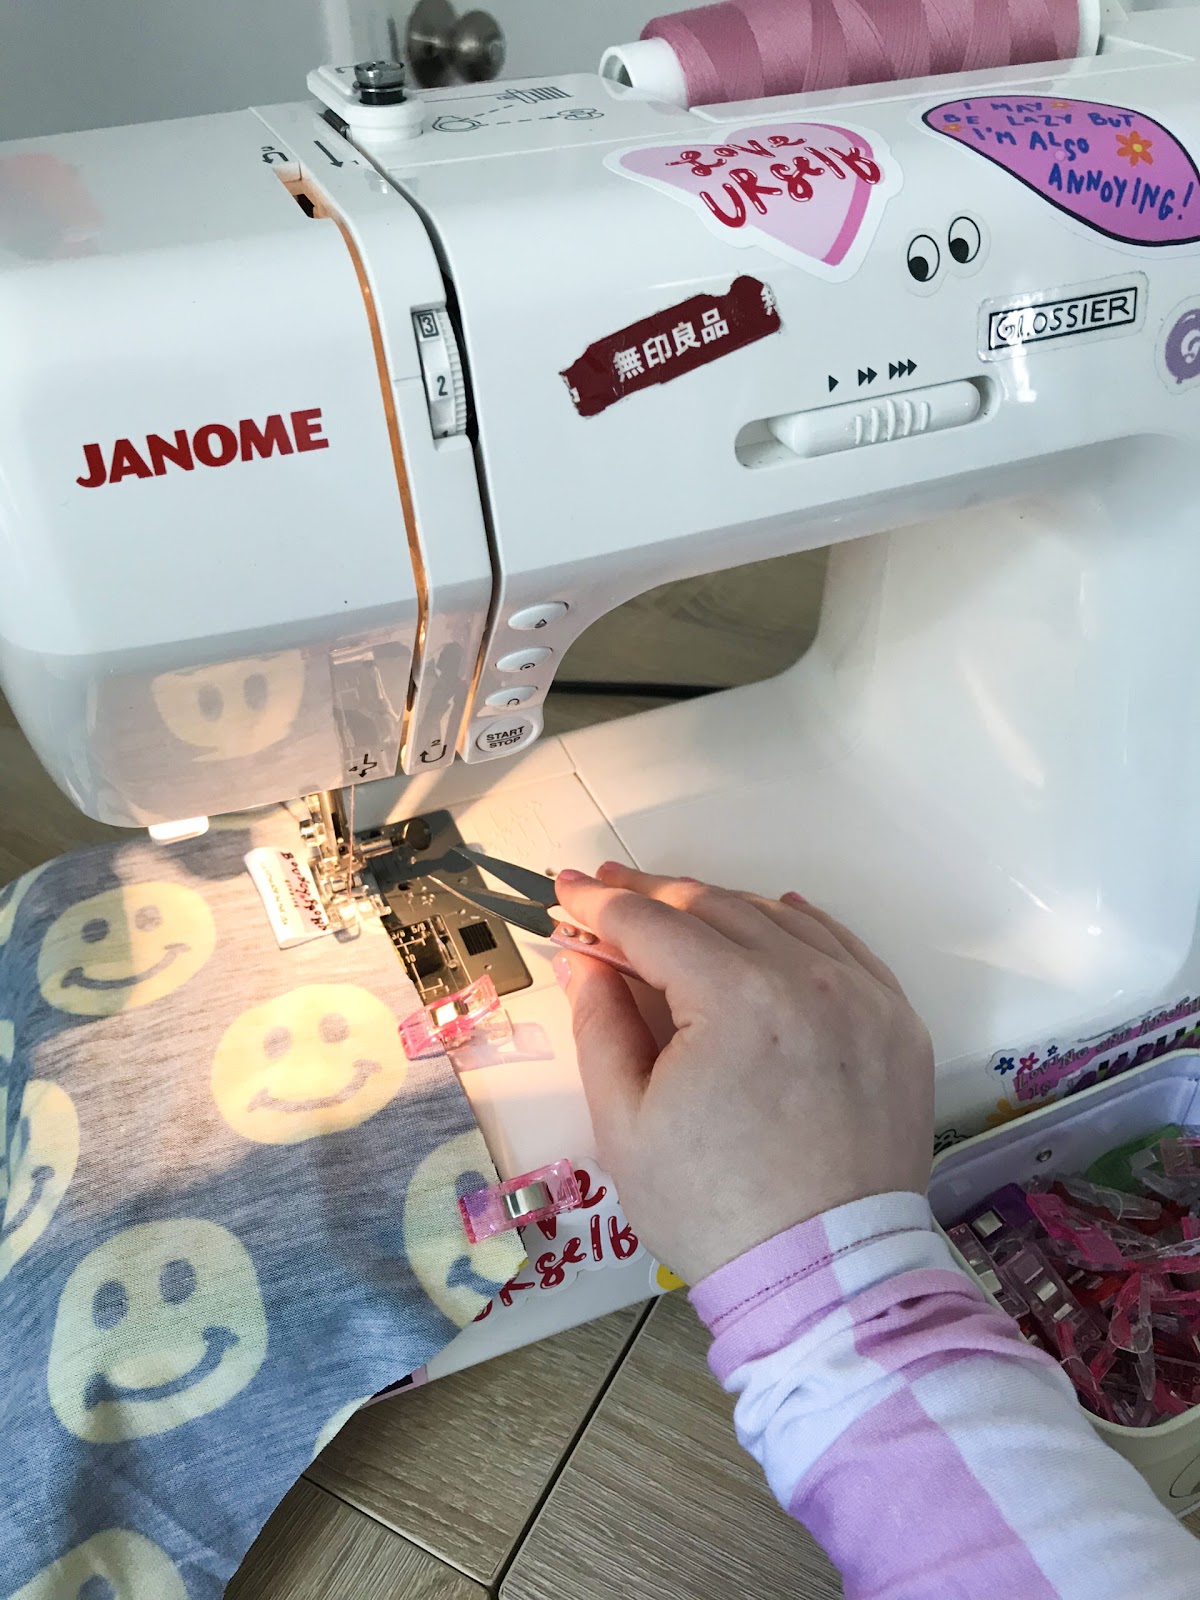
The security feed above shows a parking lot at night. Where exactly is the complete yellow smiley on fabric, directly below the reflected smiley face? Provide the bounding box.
[37,883,216,1016]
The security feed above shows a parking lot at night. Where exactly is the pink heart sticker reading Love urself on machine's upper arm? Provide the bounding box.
[606,122,901,278]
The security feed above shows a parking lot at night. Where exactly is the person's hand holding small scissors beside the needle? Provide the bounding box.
[555,862,933,1283]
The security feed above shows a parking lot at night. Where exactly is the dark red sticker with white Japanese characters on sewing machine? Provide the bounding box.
[562,277,782,416]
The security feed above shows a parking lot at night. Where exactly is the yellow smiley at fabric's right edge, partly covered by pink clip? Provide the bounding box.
[405,1128,525,1328]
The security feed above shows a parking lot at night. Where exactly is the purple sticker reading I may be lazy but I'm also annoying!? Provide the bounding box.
[925,99,1200,246]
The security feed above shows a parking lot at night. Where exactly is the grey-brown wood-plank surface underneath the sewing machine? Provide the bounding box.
[0,554,1200,1600]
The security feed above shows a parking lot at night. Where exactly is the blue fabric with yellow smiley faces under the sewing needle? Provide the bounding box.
[0,810,523,1600]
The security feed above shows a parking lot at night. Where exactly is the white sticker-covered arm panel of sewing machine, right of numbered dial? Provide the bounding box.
[366,51,1200,758]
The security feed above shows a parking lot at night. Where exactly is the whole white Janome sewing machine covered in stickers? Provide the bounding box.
[0,11,1200,1371]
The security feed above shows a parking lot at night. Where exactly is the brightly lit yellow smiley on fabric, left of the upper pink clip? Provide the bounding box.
[213,984,408,1144]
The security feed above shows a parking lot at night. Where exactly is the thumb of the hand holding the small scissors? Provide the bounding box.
[554,952,658,1142]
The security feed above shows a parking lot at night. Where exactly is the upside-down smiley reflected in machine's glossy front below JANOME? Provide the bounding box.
[150,650,304,762]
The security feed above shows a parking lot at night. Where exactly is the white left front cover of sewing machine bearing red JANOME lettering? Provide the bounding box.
[0,112,454,824]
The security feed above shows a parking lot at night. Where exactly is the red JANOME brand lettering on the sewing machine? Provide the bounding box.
[75,406,330,490]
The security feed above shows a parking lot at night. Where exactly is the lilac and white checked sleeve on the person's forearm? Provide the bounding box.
[691,1194,1200,1600]
